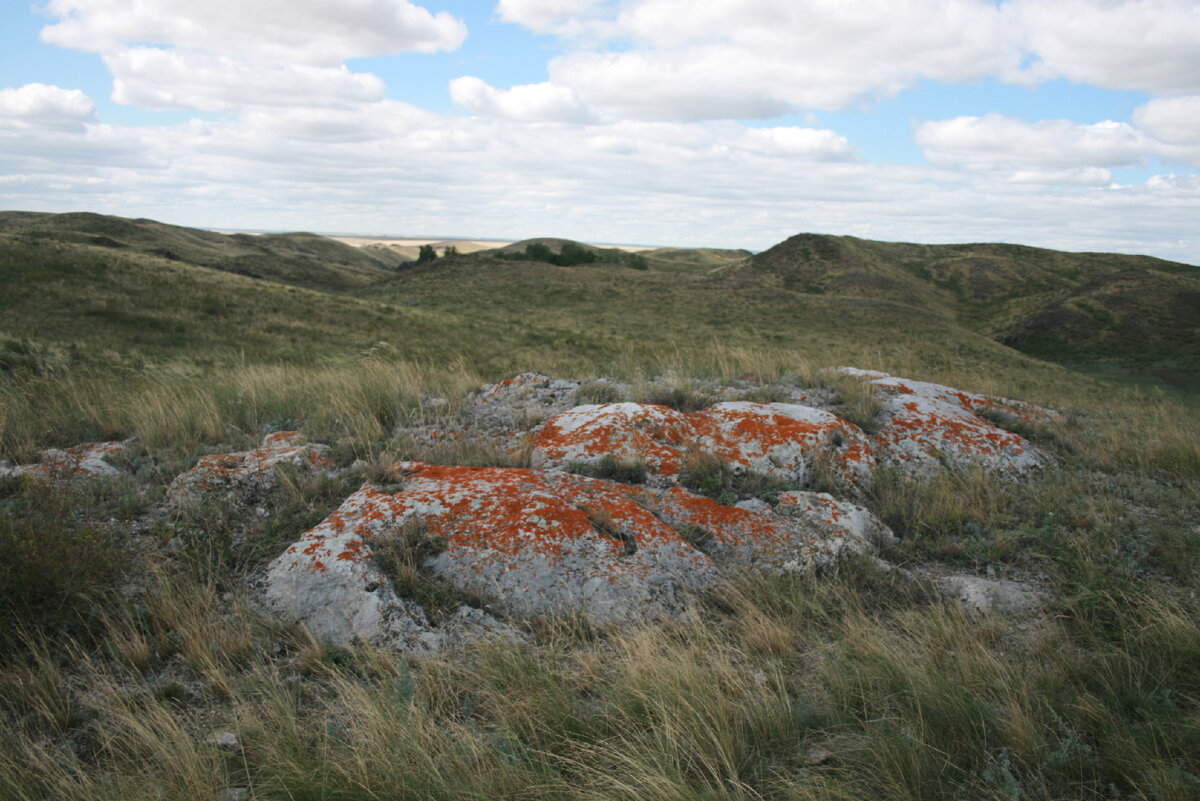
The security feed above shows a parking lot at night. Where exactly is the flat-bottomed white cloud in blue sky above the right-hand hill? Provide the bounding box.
[913,114,1158,186]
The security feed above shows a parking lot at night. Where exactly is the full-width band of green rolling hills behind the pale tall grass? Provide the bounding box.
[0,212,1200,389]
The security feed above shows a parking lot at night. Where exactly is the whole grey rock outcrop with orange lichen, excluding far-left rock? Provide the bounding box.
[260,368,1054,651]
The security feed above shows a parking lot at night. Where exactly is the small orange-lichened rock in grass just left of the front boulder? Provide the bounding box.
[169,432,334,501]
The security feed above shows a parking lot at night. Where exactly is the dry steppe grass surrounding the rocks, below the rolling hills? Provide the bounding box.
[0,348,1200,801]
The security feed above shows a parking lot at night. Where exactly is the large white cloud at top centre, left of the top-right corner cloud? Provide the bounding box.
[497,0,1021,120]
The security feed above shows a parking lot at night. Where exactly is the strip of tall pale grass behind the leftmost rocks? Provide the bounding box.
[0,359,481,459]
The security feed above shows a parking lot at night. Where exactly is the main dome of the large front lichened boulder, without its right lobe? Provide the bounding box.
[268,462,714,638]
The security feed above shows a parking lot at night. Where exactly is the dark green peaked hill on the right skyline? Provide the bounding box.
[738,234,1200,389]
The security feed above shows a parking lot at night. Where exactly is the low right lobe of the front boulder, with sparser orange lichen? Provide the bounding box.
[655,487,890,573]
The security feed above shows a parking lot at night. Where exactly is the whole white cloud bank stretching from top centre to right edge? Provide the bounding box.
[482,0,1200,120]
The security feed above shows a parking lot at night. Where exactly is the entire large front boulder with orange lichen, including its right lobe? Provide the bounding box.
[266,462,889,649]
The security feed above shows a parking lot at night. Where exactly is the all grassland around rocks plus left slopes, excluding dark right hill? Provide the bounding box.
[0,215,1200,801]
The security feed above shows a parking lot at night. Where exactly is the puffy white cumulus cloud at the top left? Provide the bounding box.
[41,0,467,110]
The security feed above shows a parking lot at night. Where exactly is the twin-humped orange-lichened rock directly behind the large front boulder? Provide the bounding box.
[533,401,874,484]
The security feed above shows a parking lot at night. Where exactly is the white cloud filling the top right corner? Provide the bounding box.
[1012,0,1200,95]
